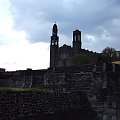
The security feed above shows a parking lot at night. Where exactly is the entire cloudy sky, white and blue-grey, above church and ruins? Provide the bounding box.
[0,0,120,71]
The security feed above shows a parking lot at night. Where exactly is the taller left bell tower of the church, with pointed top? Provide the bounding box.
[50,23,59,68]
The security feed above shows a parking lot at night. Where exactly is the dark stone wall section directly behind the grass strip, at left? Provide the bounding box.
[0,69,47,88]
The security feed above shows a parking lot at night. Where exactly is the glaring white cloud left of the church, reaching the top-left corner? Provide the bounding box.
[0,0,50,71]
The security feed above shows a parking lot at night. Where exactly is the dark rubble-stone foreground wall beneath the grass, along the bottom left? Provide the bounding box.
[0,92,97,120]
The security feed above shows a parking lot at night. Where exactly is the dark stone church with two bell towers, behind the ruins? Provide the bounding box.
[50,23,93,68]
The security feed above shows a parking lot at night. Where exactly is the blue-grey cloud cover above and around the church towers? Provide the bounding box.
[10,0,120,51]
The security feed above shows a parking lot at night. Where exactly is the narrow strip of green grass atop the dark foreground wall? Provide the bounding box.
[0,87,52,93]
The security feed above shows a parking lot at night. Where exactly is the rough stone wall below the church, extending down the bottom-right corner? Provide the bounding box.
[44,71,120,120]
